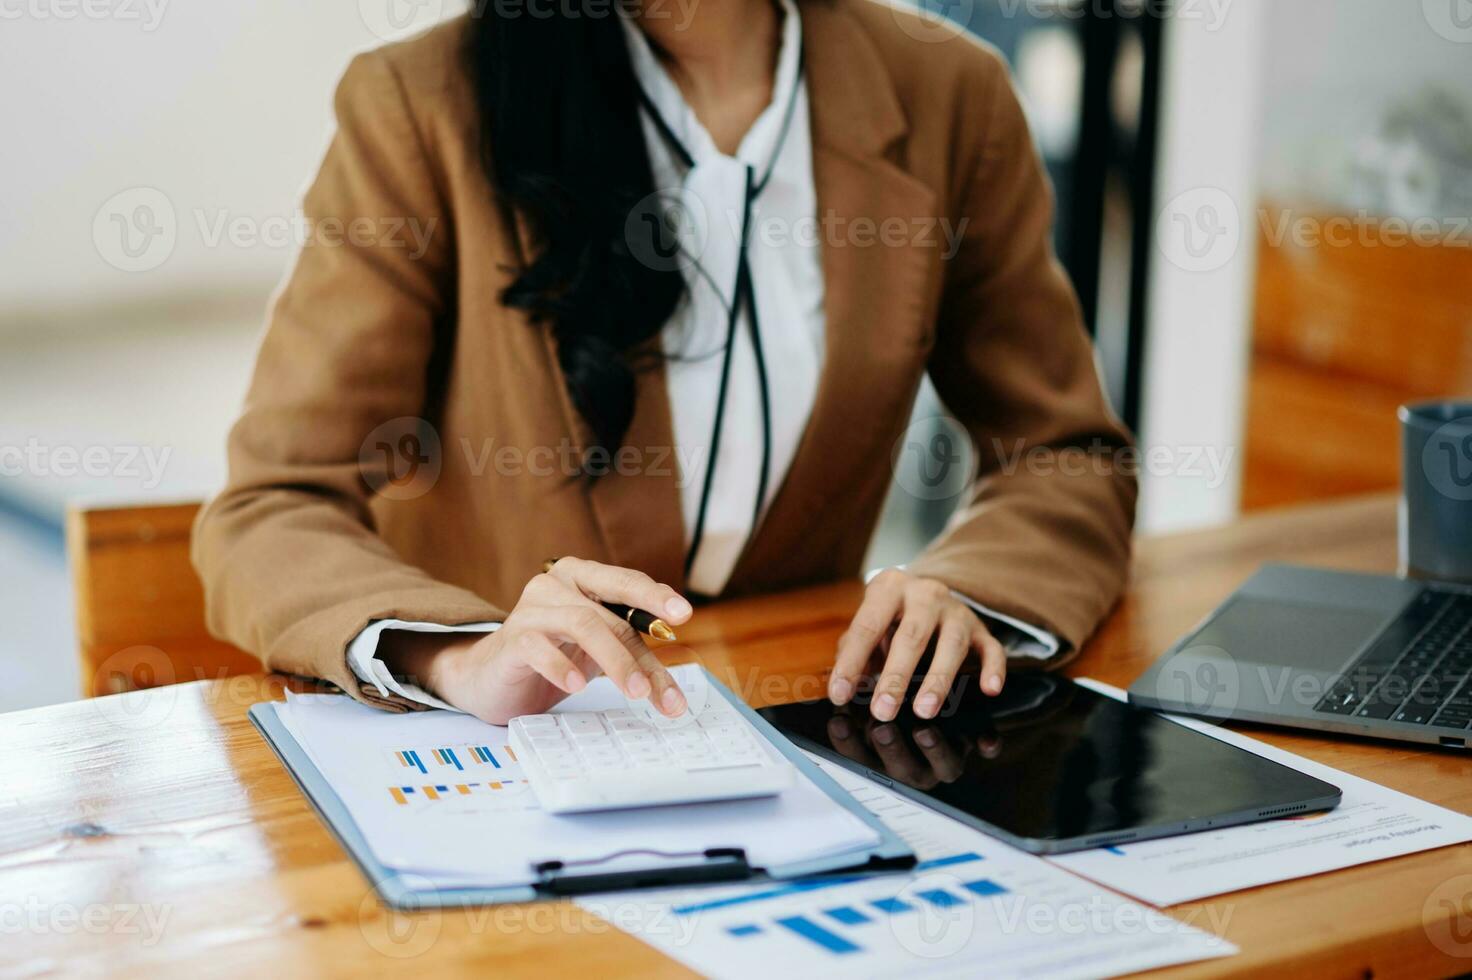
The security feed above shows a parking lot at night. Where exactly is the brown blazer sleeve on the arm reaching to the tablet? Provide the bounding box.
[908,54,1136,667]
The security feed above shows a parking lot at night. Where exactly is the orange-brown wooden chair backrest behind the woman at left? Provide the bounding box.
[66,503,261,697]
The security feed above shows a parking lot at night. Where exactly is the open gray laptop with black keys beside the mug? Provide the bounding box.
[1129,565,1472,749]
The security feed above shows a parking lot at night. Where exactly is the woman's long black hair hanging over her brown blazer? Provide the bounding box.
[464,0,684,452]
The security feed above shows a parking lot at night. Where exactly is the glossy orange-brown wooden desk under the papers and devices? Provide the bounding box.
[0,499,1472,977]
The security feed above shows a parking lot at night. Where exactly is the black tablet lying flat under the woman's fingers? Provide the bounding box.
[761,672,1340,853]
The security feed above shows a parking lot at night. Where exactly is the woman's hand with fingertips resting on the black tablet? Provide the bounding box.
[829,568,1007,721]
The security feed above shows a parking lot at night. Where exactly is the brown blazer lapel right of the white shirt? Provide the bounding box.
[729,3,941,593]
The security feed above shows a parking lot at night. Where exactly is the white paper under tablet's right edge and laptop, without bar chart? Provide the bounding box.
[1050,681,1472,905]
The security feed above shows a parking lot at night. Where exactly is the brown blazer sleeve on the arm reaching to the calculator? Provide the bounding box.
[193,53,505,711]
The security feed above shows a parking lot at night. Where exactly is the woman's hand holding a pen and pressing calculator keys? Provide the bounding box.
[381,558,692,725]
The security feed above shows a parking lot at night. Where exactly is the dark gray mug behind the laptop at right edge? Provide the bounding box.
[1400,402,1472,581]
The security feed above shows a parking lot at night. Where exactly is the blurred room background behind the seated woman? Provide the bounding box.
[0,0,1472,711]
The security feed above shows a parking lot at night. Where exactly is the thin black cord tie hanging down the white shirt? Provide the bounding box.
[639,53,804,577]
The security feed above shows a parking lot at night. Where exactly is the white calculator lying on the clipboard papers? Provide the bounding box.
[509,697,793,814]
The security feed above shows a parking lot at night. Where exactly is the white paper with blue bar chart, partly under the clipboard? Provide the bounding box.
[578,762,1236,979]
